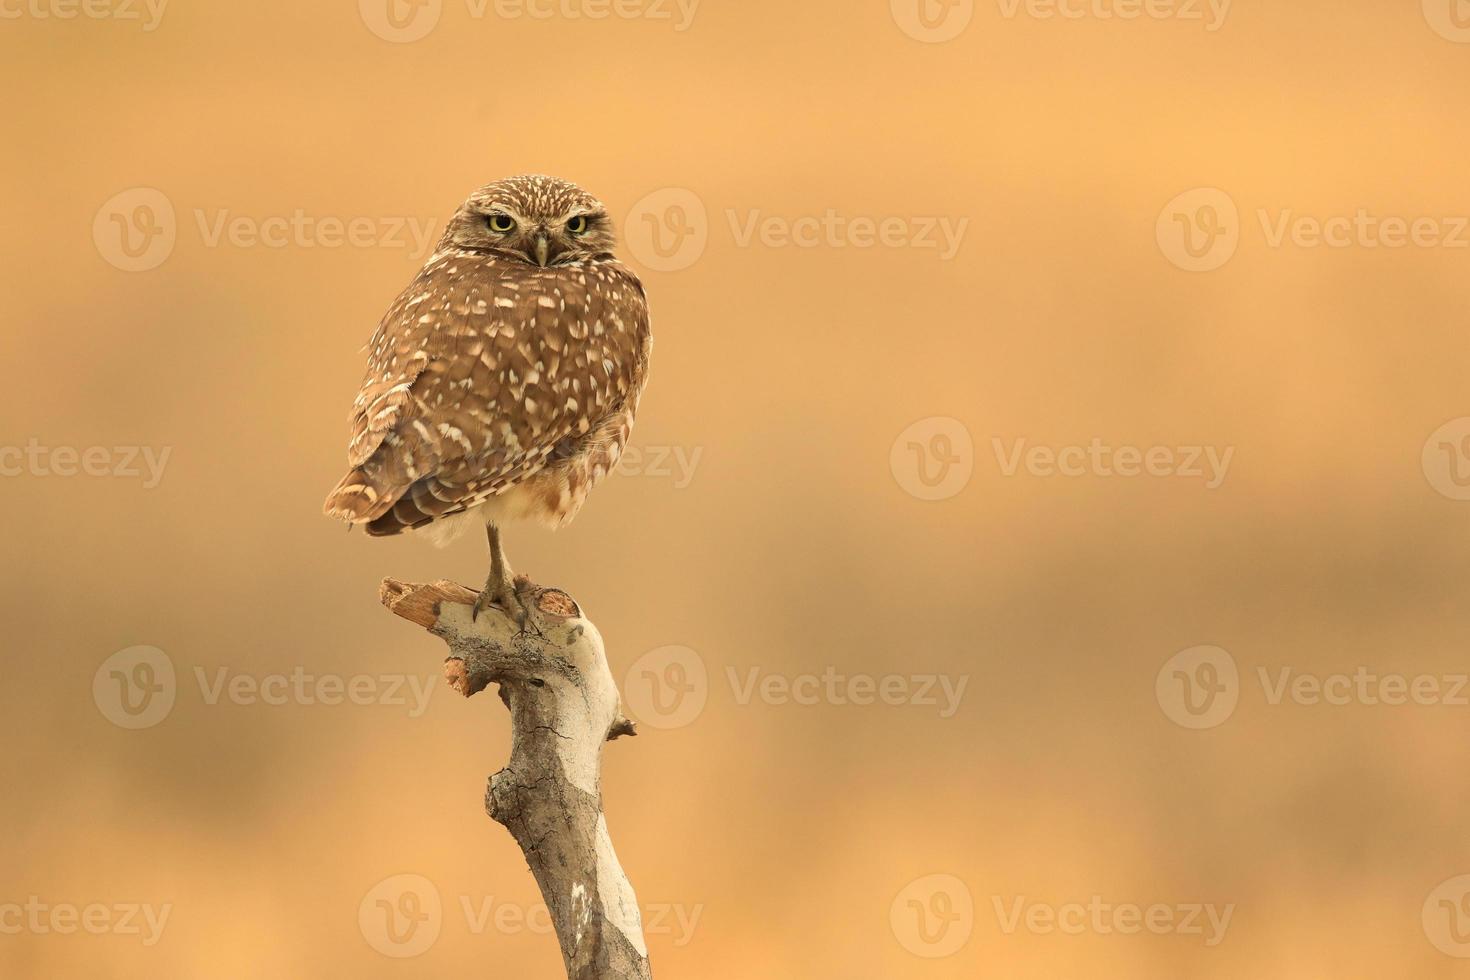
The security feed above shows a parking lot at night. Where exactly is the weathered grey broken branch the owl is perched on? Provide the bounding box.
[379,579,651,980]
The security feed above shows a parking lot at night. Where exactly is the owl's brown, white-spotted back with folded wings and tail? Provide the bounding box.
[326,254,650,533]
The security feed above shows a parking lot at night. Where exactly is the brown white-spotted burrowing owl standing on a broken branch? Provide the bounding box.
[325,176,653,619]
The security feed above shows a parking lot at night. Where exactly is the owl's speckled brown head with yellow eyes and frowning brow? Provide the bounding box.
[441,175,616,267]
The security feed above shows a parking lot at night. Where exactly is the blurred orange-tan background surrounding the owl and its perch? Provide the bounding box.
[0,0,1470,980]
